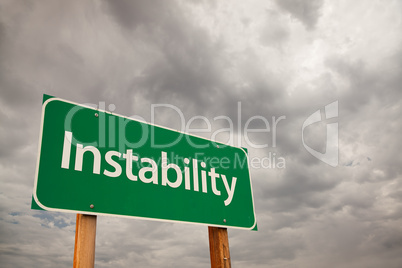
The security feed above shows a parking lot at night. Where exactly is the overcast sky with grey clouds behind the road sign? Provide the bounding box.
[0,0,402,268]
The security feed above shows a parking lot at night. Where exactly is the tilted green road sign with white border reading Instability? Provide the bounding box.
[32,95,256,229]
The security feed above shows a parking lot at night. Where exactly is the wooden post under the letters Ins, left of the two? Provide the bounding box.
[73,214,96,268]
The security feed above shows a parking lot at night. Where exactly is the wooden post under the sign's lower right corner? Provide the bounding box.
[208,226,231,268]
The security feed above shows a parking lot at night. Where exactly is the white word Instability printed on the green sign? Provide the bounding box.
[61,131,237,206]
